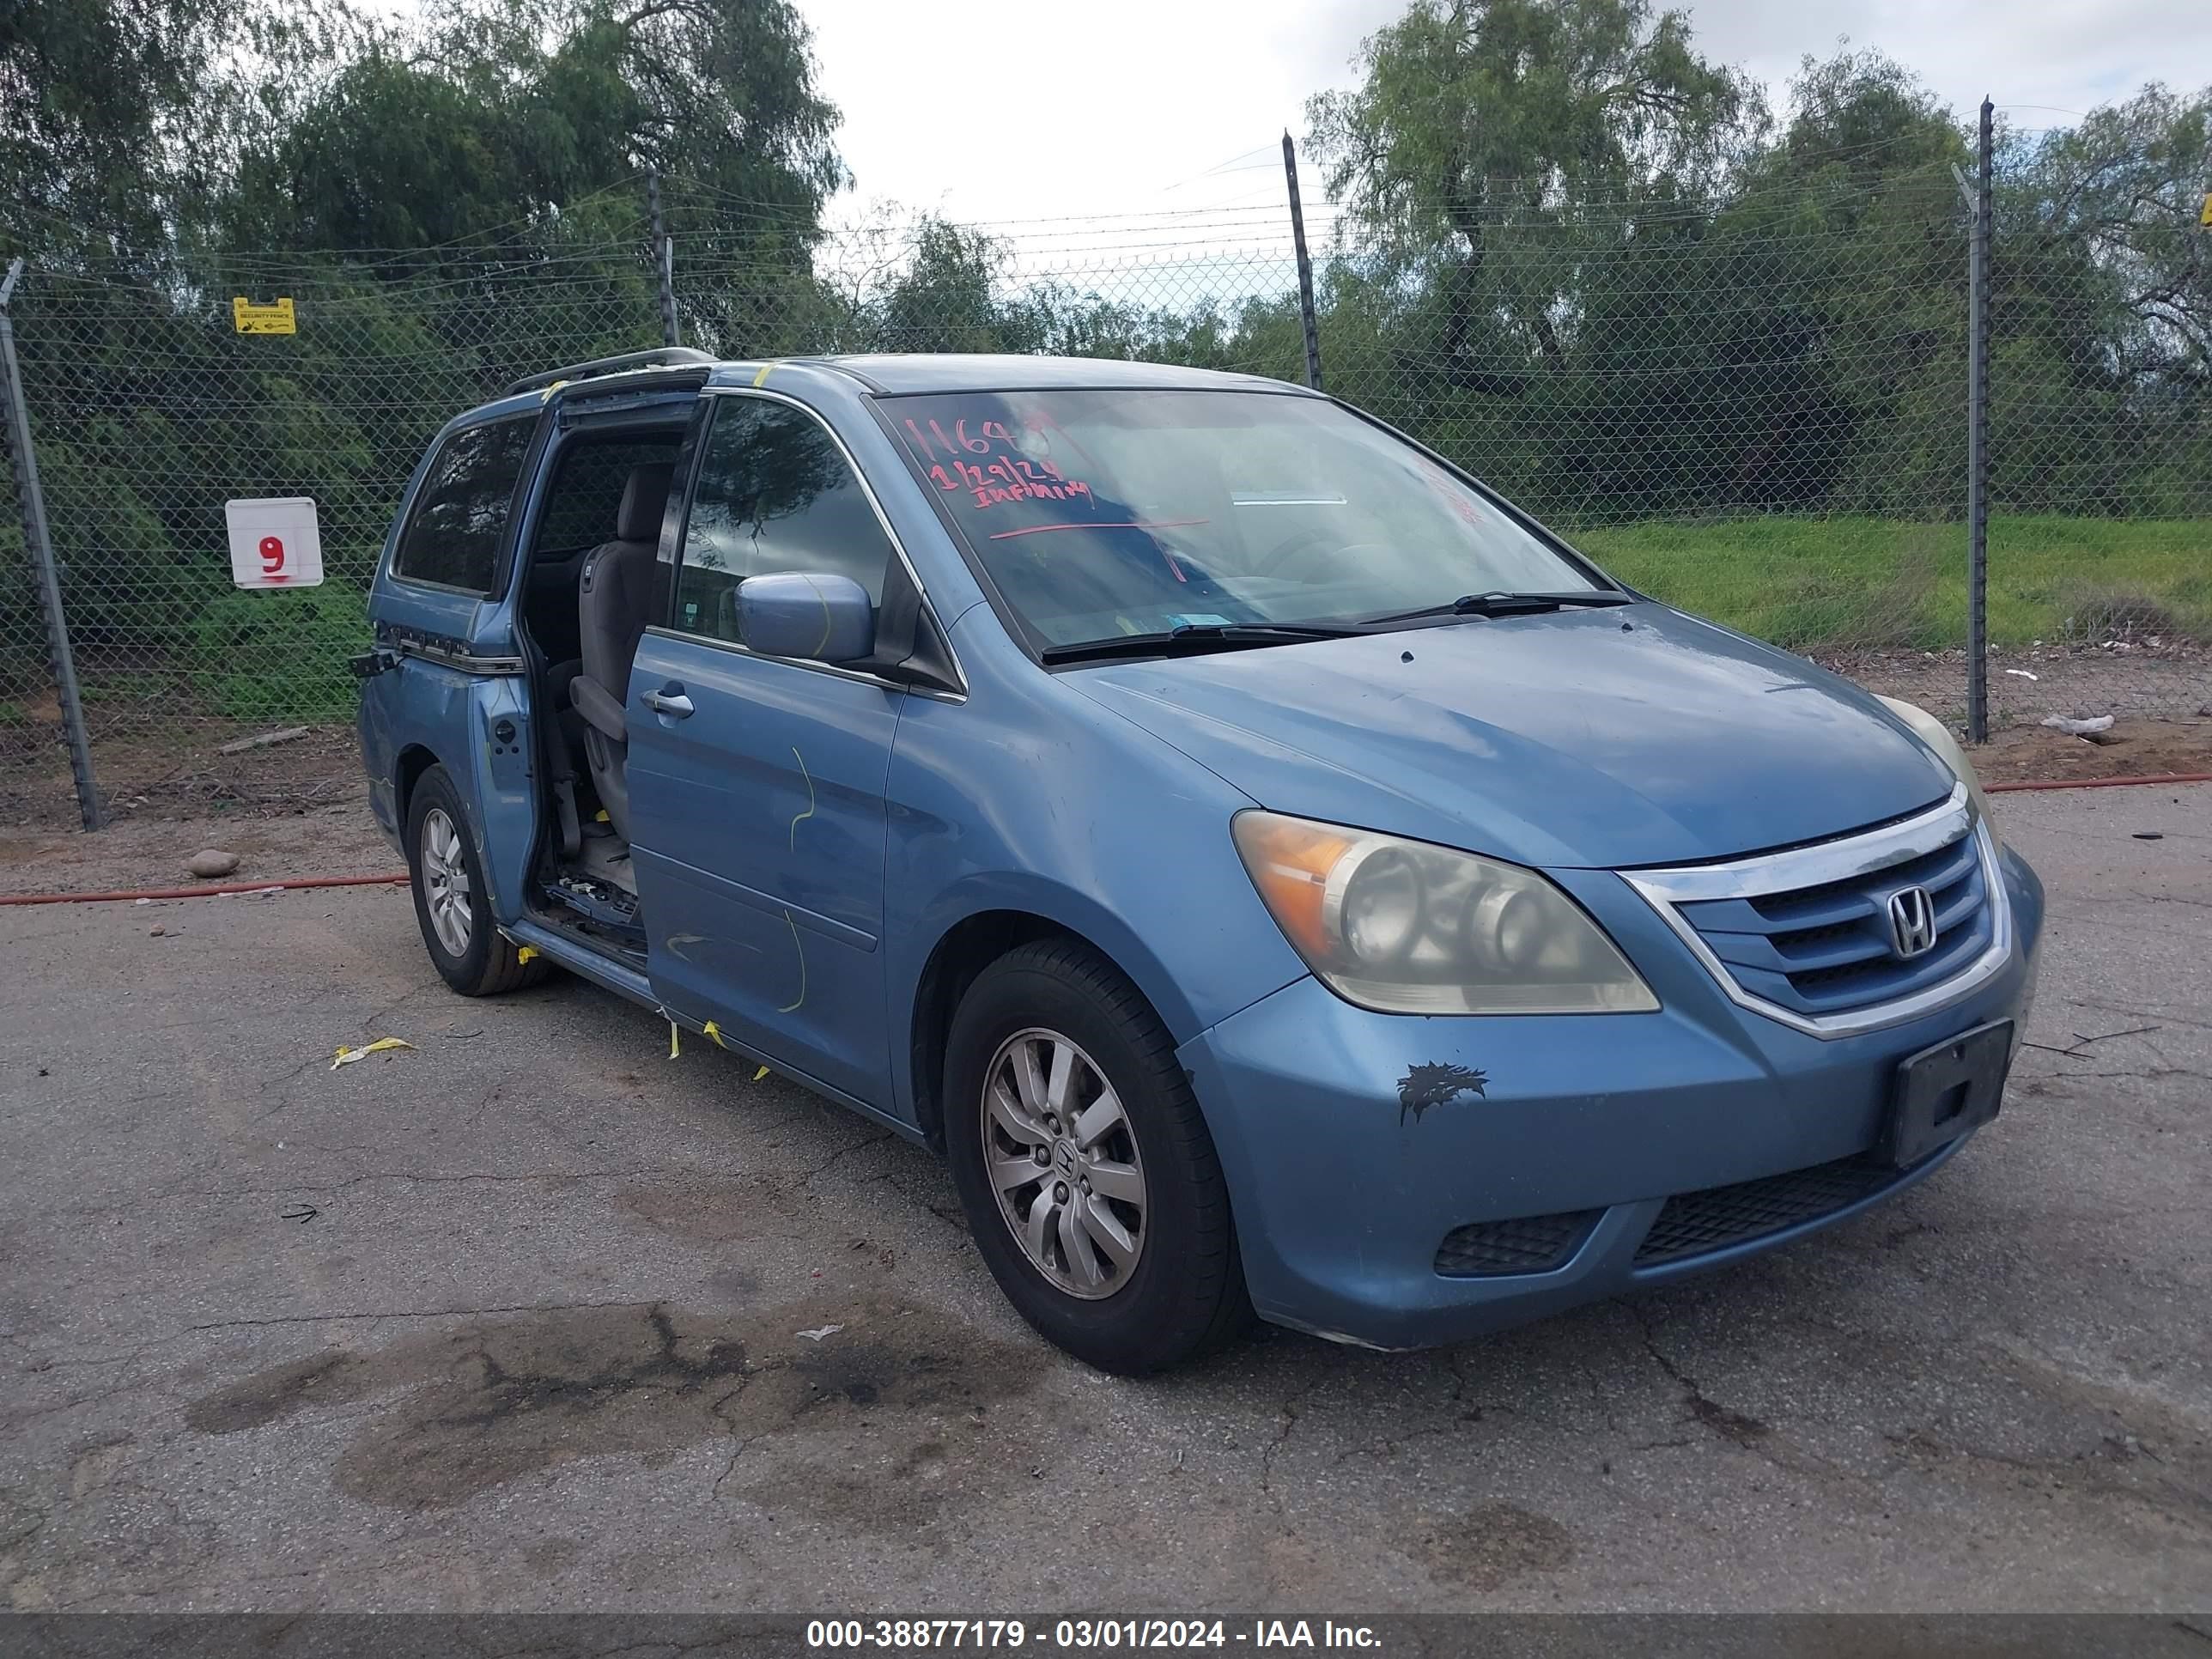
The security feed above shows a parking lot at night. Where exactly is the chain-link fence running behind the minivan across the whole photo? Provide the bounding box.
[0,153,2212,823]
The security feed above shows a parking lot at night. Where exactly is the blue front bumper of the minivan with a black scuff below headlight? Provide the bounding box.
[1179,849,2044,1349]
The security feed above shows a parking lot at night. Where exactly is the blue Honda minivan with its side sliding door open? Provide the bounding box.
[356,349,2042,1371]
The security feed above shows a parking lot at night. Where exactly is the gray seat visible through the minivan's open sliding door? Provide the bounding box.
[568,460,672,841]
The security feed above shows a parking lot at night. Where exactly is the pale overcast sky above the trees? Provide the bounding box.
[796,0,2212,223]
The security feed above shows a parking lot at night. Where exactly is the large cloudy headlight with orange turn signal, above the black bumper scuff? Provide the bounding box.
[1230,811,1659,1013]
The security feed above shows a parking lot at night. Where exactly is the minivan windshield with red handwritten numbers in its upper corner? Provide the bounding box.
[883,389,1599,646]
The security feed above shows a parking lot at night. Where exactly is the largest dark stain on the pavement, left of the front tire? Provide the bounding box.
[185,1297,1046,1510]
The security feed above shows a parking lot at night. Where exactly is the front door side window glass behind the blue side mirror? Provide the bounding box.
[677,398,891,644]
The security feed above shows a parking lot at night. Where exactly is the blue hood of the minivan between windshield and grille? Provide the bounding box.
[1064,604,1951,867]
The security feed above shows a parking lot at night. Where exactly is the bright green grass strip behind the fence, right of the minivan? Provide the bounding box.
[1573,514,2212,650]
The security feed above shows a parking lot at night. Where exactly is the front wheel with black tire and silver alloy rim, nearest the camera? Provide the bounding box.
[942,940,1252,1376]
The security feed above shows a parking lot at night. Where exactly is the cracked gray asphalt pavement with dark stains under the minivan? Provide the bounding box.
[0,785,2212,1613]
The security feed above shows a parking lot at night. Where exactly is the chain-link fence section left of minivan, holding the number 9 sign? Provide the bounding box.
[0,250,659,818]
